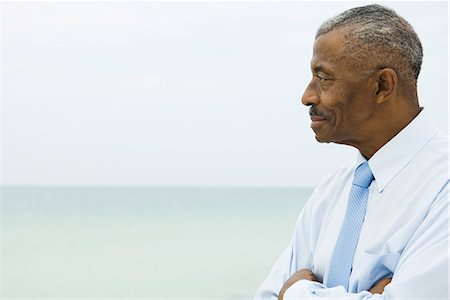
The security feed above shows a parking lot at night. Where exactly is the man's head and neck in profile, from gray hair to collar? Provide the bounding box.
[302,5,422,157]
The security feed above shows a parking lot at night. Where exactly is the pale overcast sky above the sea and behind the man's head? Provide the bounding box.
[1,1,449,187]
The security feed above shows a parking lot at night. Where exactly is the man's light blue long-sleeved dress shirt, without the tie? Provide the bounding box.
[255,110,449,300]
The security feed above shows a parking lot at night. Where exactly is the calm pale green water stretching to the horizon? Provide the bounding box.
[2,187,311,299]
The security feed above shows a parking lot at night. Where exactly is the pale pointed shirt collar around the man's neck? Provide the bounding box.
[357,109,438,192]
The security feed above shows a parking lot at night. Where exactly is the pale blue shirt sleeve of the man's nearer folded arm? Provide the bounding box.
[284,185,449,300]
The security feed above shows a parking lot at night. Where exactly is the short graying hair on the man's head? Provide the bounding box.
[316,4,423,83]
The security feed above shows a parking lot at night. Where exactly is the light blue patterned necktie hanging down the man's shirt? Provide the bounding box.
[327,162,373,290]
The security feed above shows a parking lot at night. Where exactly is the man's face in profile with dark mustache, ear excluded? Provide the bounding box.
[302,30,376,145]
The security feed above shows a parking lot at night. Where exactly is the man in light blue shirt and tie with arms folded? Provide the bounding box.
[255,5,449,300]
